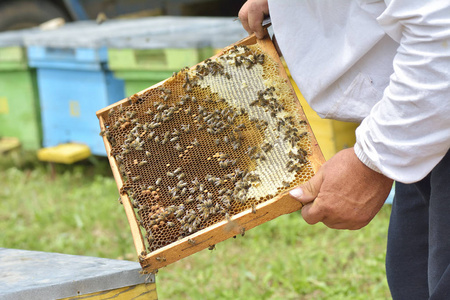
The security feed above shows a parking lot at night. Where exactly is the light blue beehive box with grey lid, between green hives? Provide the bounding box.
[25,22,124,155]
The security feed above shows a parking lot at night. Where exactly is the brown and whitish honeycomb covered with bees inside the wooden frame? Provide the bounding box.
[101,44,313,252]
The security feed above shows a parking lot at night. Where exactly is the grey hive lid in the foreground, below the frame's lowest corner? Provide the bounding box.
[0,248,154,300]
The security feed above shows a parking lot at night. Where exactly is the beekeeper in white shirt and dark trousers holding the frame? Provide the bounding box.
[239,0,450,299]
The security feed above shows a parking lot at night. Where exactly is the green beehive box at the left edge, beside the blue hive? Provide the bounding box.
[0,30,42,150]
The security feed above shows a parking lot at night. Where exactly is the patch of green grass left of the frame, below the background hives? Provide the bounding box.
[0,151,134,258]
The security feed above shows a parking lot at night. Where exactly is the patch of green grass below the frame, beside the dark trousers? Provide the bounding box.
[158,207,390,299]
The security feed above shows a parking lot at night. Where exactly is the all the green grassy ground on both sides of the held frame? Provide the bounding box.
[0,153,390,299]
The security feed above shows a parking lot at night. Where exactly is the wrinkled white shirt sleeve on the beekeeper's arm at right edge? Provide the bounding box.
[355,0,450,183]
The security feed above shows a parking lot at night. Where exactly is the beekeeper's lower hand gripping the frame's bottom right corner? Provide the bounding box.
[290,148,393,229]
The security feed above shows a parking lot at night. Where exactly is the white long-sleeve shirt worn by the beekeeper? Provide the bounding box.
[269,0,450,183]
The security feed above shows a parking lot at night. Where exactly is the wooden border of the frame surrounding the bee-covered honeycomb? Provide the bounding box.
[97,35,325,272]
